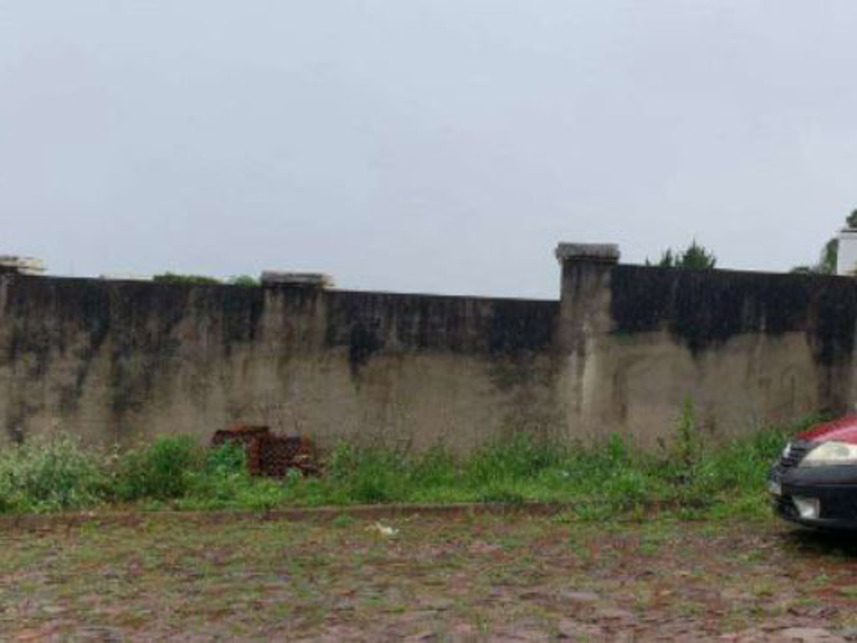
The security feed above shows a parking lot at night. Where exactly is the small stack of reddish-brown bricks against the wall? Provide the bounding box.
[212,424,319,478]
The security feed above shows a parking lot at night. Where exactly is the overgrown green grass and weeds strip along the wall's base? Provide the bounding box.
[0,418,810,521]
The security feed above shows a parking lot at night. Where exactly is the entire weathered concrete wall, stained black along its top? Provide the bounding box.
[0,252,857,451]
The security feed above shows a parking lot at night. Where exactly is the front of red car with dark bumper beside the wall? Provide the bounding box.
[768,415,857,529]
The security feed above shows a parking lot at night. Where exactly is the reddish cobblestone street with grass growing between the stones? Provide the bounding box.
[0,516,857,641]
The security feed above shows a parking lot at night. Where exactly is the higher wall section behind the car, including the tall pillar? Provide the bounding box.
[560,261,857,445]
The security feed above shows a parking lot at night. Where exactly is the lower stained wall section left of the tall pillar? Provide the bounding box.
[0,276,564,450]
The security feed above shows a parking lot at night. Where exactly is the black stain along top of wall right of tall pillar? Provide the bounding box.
[611,266,857,365]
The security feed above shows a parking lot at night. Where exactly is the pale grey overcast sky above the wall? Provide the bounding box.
[0,0,857,298]
